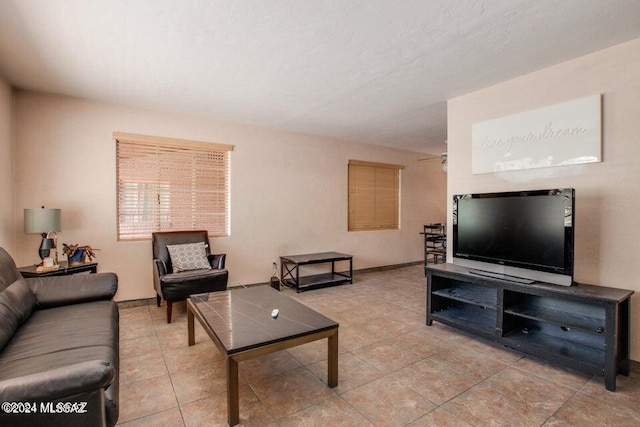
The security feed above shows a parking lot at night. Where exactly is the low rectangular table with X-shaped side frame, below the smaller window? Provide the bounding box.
[280,252,353,292]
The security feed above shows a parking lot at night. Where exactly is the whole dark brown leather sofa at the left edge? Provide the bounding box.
[0,248,119,427]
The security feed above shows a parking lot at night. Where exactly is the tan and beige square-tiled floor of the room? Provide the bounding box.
[119,266,640,427]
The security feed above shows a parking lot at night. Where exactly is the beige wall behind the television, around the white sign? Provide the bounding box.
[447,39,640,360]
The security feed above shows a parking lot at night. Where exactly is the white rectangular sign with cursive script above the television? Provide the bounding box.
[471,95,602,174]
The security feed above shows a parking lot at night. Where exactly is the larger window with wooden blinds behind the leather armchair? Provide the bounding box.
[113,132,233,240]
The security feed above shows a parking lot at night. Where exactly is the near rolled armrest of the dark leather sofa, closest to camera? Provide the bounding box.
[0,360,116,402]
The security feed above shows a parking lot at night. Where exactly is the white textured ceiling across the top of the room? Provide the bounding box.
[0,0,640,152]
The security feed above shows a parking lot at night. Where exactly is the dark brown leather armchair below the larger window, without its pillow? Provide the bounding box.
[151,230,229,323]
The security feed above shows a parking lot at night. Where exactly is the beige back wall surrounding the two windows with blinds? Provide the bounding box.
[14,91,446,300]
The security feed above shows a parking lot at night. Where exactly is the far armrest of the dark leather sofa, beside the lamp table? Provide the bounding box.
[25,273,118,308]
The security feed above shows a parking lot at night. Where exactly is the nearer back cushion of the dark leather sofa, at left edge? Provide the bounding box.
[0,279,36,349]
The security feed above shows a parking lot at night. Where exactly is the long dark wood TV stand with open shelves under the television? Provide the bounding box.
[426,264,633,391]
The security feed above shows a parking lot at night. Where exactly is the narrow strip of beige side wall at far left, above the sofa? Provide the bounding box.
[0,77,14,253]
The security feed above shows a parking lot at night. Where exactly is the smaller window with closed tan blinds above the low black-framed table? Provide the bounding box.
[348,160,404,231]
